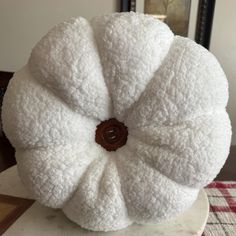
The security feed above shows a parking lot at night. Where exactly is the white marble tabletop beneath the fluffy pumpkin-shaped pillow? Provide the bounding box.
[0,166,209,236]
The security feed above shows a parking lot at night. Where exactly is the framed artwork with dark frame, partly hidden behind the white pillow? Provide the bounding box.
[121,0,215,49]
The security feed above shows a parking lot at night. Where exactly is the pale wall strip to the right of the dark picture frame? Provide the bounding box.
[210,0,236,145]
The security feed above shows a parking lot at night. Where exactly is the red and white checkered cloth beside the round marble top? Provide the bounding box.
[202,181,236,236]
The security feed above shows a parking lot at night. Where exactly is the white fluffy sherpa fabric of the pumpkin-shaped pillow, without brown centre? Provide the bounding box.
[2,13,231,231]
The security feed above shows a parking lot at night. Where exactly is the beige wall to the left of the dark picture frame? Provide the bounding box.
[0,0,119,71]
